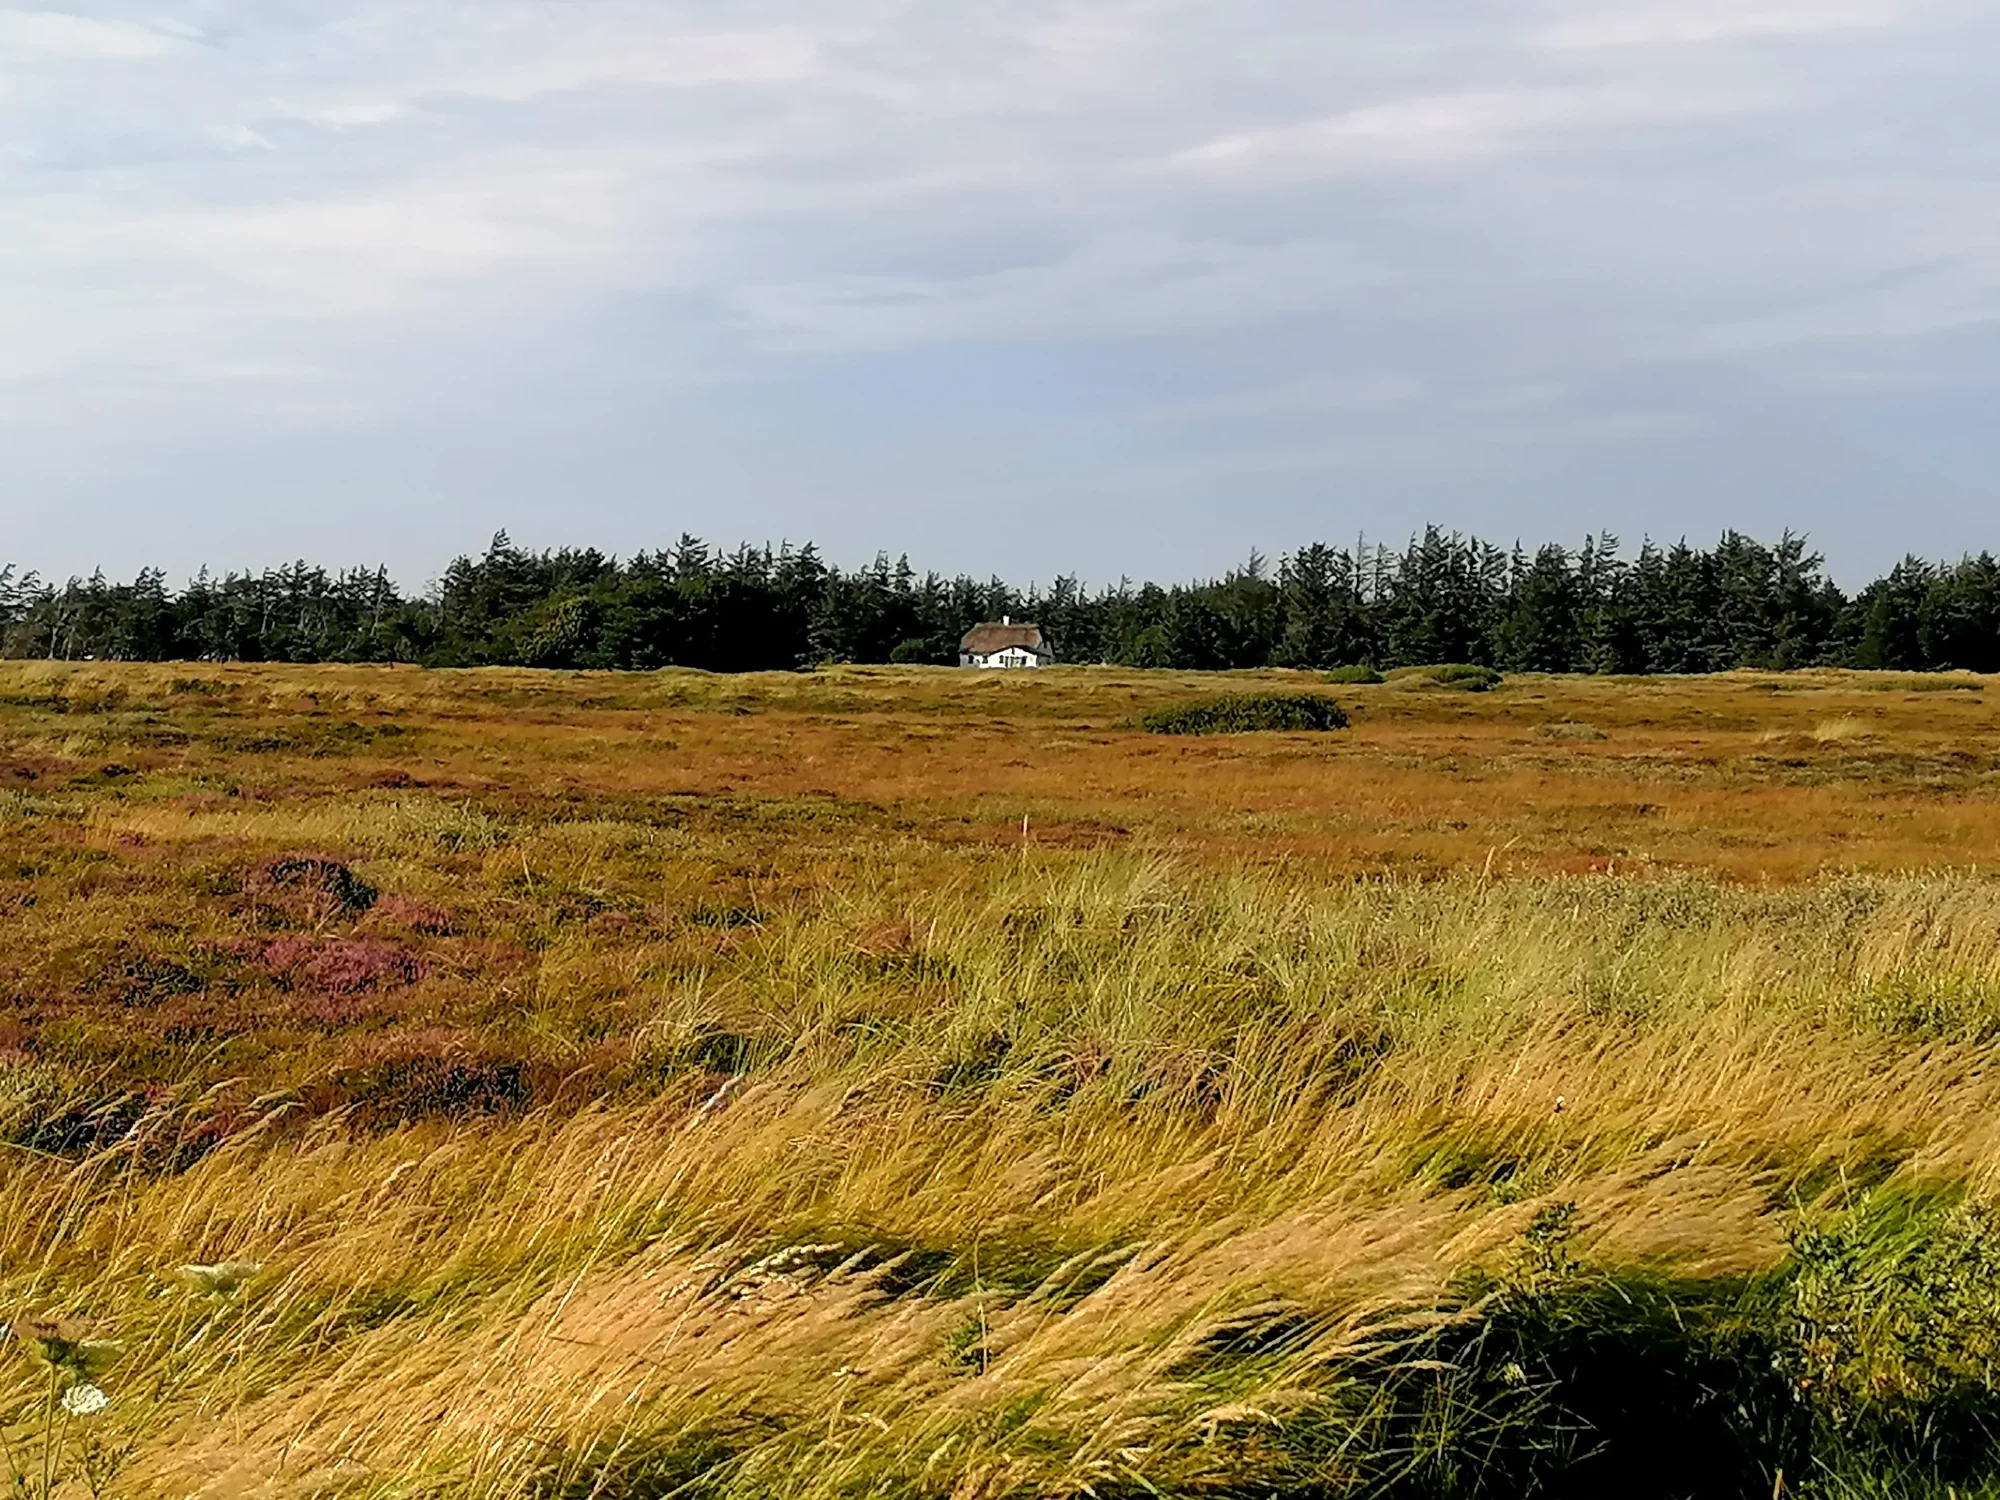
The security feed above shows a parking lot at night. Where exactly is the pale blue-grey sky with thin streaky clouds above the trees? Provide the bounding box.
[0,0,2000,584]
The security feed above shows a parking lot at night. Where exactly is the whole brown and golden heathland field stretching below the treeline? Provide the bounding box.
[0,664,2000,1500]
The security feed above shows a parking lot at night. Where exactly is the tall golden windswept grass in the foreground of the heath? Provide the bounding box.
[0,854,2000,1496]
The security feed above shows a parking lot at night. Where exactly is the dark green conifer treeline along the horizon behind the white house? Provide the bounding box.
[0,528,2000,672]
